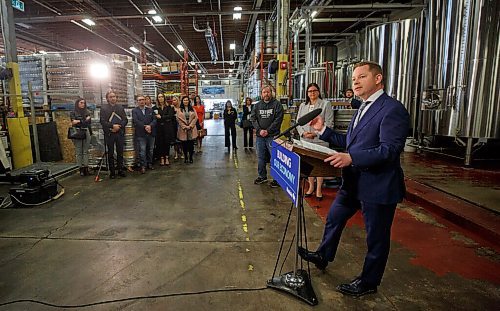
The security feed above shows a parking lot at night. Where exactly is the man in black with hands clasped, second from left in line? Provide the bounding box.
[100,91,128,179]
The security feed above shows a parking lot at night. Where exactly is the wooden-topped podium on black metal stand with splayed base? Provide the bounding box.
[267,139,341,306]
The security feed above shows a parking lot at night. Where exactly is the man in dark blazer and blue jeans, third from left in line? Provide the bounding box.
[132,96,156,174]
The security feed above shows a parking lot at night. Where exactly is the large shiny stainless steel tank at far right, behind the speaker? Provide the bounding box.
[421,0,500,139]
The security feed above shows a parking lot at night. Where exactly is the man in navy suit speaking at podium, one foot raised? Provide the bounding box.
[299,62,409,296]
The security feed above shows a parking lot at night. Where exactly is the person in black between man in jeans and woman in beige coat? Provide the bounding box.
[153,93,176,166]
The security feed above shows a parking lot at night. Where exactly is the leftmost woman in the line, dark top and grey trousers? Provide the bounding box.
[70,98,92,176]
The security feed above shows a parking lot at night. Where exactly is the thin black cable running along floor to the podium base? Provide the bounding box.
[0,287,268,309]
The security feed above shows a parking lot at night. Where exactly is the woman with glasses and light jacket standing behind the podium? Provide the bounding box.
[297,83,333,201]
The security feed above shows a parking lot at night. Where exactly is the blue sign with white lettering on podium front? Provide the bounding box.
[271,141,300,206]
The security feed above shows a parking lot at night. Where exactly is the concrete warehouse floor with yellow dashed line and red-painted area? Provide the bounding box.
[0,120,500,310]
